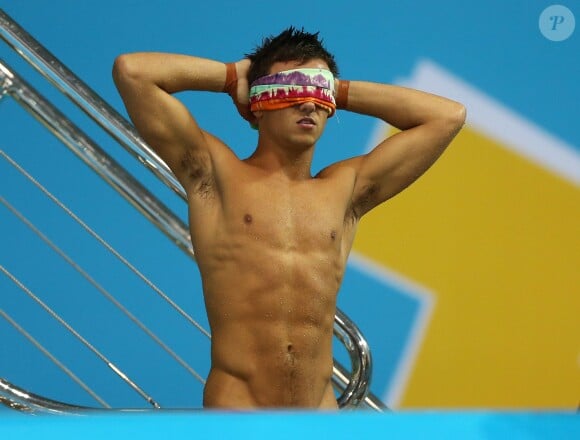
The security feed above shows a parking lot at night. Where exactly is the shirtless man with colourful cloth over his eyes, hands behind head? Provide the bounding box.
[113,28,465,409]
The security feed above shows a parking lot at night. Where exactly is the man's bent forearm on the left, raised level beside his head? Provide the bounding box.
[113,52,226,93]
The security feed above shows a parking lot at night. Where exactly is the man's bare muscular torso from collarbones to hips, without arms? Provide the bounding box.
[182,143,356,408]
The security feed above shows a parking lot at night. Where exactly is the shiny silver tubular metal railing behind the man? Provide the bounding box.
[0,9,385,412]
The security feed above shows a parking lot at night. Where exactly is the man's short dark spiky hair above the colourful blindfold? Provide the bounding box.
[245,26,338,84]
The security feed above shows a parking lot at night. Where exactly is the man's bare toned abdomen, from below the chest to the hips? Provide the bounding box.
[200,239,338,409]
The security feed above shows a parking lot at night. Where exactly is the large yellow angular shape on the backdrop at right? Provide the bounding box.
[354,127,580,408]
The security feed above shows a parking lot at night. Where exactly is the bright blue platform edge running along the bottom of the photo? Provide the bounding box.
[0,411,580,440]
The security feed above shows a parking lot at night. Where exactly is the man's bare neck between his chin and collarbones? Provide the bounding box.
[246,140,314,180]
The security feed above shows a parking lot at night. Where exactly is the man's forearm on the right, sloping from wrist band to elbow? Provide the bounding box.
[338,81,465,130]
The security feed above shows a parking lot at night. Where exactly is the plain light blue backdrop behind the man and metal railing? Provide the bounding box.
[0,0,580,407]
